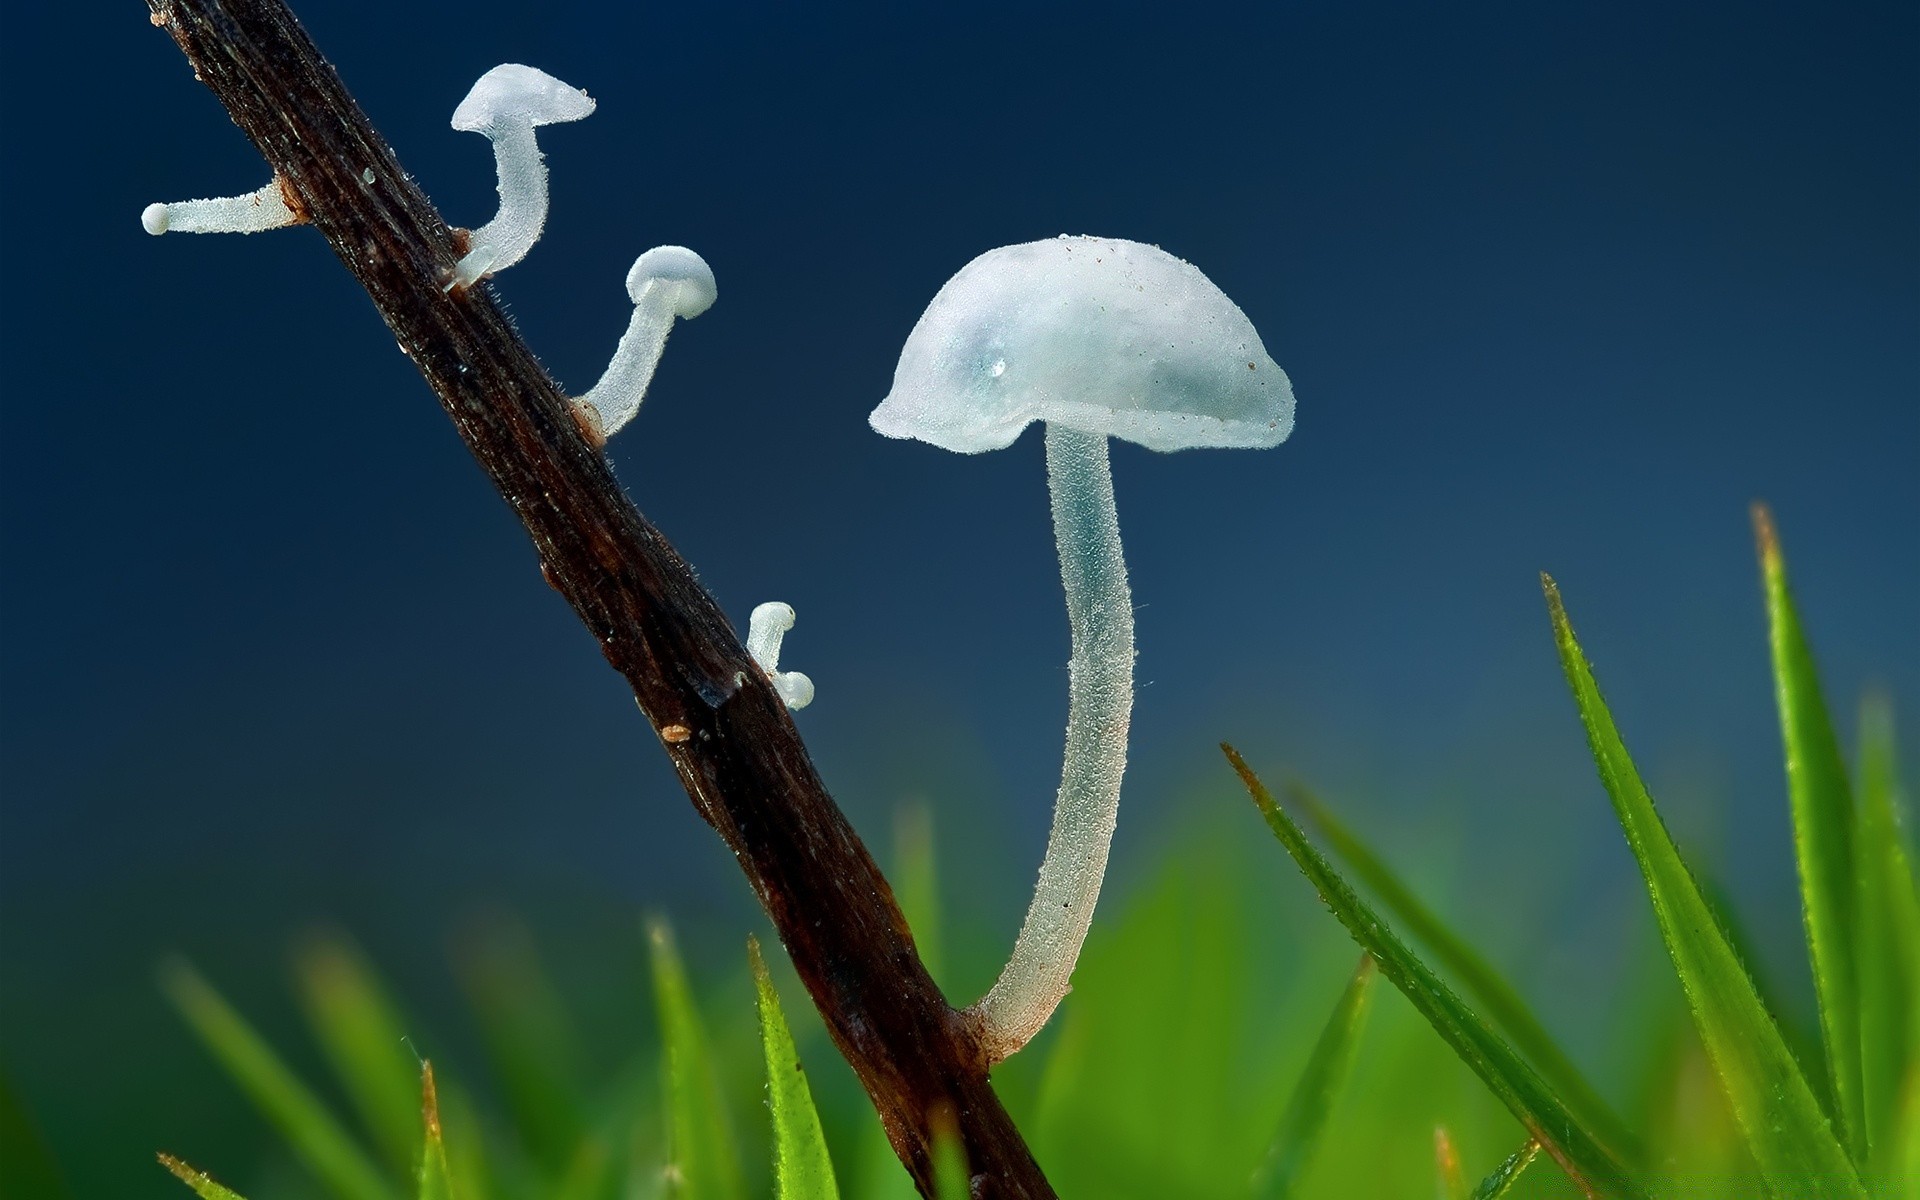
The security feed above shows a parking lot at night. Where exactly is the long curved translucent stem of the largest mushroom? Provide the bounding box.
[966,422,1133,1064]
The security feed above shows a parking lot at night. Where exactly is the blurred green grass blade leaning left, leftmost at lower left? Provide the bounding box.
[161,962,394,1200]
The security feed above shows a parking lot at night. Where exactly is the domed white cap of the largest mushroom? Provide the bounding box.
[868,234,1294,453]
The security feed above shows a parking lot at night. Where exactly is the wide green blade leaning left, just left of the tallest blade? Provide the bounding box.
[1542,576,1866,1200]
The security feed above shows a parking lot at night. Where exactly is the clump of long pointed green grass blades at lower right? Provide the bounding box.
[1225,507,1920,1200]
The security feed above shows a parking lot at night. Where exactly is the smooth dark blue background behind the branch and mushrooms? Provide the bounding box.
[0,0,1920,1188]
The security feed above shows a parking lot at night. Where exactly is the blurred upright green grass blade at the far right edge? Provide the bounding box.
[1853,699,1920,1167]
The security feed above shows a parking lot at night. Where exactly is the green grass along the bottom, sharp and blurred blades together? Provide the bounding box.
[18,513,1920,1200]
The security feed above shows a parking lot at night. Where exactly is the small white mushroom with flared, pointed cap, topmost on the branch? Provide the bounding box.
[449,63,593,290]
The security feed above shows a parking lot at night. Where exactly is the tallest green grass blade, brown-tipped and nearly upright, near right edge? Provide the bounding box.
[1753,503,1866,1162]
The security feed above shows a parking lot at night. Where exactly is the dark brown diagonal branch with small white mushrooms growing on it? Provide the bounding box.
[150,0,1054,1198]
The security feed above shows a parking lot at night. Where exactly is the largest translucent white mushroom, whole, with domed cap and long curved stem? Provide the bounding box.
[868,236,1294,1062]
